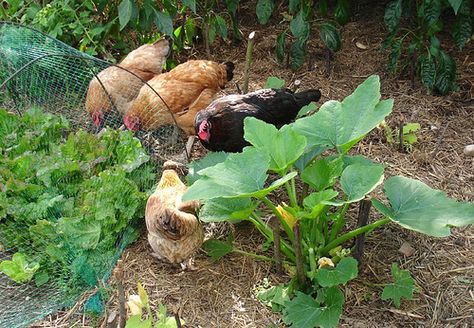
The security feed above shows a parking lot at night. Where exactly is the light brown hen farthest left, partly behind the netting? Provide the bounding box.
[86,36,171,127]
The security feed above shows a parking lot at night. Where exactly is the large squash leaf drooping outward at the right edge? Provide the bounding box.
[372,176,474,237]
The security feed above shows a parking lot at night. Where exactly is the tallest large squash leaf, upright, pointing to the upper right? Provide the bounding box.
[294,75,393,153]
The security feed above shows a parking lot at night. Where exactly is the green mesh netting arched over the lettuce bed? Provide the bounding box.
[0,22,184,327]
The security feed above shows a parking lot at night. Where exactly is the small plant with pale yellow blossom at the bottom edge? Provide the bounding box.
[125,283,185,328]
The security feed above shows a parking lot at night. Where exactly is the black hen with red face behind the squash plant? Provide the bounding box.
[194,89,321,152]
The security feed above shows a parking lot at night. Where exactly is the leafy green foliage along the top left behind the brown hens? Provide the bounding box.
[0,0,241,60]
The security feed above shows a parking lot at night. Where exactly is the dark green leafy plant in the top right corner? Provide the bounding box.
[384,0,472,95]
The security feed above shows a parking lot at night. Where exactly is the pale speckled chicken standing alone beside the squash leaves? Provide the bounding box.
[145,163,204,269]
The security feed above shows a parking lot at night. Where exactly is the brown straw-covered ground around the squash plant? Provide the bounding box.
[38,1,474,328]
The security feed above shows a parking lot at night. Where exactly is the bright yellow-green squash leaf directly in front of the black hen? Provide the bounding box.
[244,117,306,173]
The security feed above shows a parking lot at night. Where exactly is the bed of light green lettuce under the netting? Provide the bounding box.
[0,108,155,292]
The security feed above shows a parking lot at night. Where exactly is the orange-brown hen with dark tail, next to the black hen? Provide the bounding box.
[124,60,234,135]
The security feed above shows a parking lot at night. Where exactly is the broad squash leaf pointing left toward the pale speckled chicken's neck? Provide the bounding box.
[183,147,270,200]
